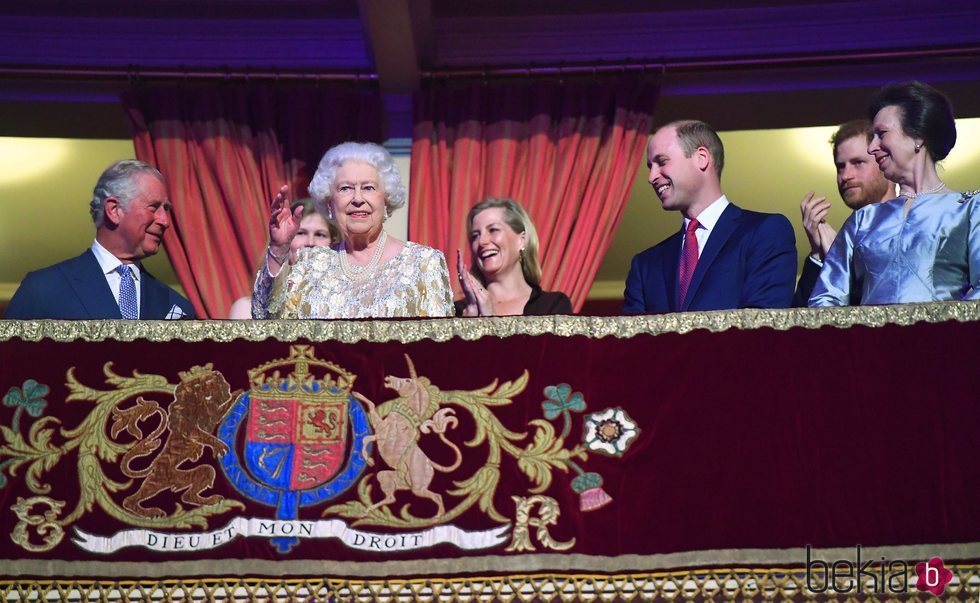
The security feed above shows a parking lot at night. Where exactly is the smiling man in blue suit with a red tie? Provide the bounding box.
[623,120,796,313]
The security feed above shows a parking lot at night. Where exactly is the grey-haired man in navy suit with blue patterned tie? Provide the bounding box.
[4,160,194,319]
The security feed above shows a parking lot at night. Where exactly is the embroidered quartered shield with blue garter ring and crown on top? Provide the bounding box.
[219,345,370,552]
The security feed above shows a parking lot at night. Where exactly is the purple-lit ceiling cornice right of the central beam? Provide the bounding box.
[433,0,980,68]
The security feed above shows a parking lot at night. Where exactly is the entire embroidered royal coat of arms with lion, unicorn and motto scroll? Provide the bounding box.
[0,345,639,555]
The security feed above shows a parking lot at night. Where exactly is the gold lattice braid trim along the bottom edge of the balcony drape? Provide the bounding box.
[0,564,980,603]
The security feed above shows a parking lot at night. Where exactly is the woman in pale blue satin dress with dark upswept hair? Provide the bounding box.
[809,82,980,307]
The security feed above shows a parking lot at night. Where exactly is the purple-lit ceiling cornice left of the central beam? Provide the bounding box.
[0,17,373,71]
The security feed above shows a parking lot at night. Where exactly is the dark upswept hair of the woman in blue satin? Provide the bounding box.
[868,82,956,161]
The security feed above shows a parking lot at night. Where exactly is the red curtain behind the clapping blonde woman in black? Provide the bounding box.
[409,76,658,310]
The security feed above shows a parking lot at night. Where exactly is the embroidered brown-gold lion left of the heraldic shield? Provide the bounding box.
[111,363,240,517]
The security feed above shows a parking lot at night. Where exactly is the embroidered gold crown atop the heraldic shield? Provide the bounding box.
[249,345,357,398]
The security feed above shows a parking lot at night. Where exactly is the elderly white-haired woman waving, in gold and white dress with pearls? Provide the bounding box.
[252,142,453,318]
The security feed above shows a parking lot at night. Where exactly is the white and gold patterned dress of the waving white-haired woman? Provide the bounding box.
[252,241,453,318]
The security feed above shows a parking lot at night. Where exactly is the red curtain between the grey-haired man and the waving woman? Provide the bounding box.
[123,82,382,318]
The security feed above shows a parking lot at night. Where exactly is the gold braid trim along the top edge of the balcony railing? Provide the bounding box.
[0,302,980,343]
